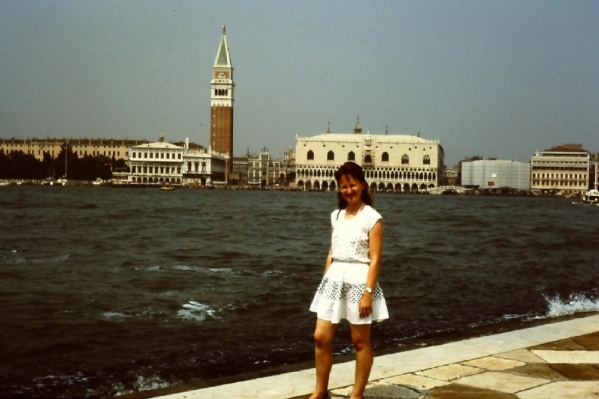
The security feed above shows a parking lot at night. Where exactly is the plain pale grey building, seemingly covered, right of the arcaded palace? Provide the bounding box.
[462,159,530,192]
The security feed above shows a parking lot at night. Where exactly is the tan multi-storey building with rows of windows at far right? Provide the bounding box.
[530,144,590,195]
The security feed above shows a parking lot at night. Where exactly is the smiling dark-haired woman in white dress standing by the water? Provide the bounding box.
[310,162,389,399]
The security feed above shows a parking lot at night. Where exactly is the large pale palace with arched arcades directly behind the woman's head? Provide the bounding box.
[295,120,444,192]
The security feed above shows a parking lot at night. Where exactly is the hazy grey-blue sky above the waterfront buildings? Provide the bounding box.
[0,0,599,165]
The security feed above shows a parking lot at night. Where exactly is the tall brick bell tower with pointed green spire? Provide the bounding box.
[210,26,235,173]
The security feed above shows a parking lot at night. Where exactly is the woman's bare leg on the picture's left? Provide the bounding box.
[310,318,337,399]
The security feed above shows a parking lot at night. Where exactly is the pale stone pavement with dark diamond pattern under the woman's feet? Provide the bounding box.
[155,314,599,399]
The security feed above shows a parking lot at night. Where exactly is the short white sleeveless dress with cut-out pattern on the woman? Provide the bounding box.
[310,205,389,324]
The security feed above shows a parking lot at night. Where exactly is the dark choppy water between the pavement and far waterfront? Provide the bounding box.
[0,186,599,397]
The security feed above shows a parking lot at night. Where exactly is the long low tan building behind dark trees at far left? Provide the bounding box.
[0,138,148,161]
